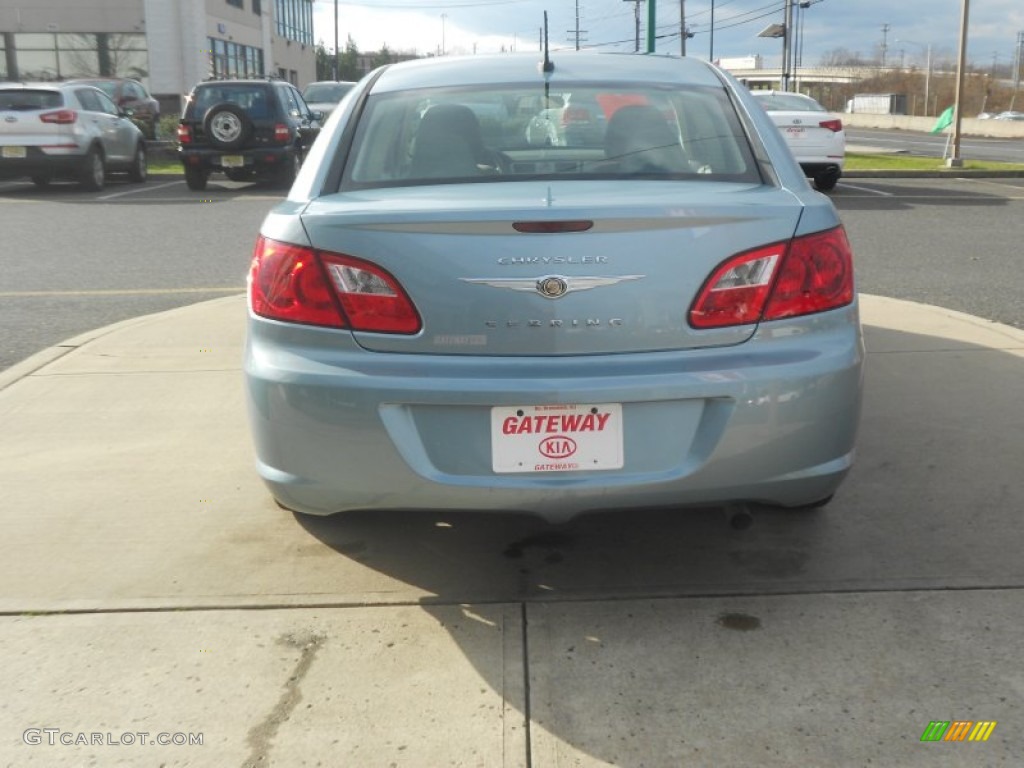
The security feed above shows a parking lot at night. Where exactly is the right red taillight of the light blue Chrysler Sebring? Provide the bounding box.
[689,226,853,328]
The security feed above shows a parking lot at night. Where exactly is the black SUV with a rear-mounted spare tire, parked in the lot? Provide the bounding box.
[178,79,323,189]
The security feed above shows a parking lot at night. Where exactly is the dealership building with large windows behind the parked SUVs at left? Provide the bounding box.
[0,0,315,114]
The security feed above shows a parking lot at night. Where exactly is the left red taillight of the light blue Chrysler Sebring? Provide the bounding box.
[249,237,422,334]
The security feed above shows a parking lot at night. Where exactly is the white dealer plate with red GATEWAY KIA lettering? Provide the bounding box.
[490,402,623,473]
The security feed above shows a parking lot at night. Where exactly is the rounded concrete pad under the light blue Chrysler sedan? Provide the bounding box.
[0,296,1024,768]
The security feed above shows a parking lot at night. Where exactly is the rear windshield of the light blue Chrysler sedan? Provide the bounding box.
[342,84,760,188]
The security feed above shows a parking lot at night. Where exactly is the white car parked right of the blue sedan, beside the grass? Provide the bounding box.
[753,91,846,191]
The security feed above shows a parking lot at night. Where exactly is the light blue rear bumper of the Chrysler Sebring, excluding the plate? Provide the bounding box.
[245,304,863,521]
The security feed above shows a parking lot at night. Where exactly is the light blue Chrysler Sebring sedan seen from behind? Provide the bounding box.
[244,52,863,521]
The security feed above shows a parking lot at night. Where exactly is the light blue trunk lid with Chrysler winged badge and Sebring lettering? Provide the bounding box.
[302,181,802,355]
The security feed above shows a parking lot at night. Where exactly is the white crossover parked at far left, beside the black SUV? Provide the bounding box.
[0,83,147,190]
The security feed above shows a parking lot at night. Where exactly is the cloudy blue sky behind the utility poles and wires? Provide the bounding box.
[313,0,1024,69]
